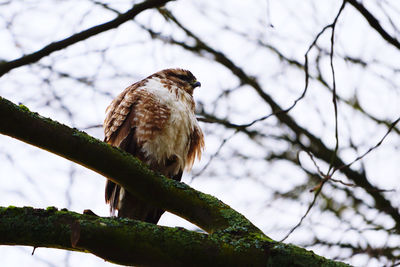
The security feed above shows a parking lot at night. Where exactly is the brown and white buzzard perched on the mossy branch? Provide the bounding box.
[103,69,204,224]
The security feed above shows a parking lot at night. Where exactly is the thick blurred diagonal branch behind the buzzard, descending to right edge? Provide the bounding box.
[143,13,400,232]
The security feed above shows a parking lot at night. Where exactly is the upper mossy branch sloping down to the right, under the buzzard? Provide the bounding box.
[0,97,262,237]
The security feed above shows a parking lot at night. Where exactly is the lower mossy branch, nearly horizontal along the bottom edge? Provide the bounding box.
[0,207,347,266]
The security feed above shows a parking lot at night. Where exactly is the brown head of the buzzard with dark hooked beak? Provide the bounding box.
[158,69,201,95]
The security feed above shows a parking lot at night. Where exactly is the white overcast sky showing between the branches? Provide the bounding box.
[0,0,400,266]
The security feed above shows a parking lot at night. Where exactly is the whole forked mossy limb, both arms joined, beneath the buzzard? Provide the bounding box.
[0,97,346,266]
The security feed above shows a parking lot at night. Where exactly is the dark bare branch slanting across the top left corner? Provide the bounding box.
[0,0,172,77]
